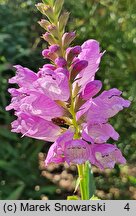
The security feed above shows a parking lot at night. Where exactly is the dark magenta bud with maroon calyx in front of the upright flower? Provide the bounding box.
[70,60,88,81]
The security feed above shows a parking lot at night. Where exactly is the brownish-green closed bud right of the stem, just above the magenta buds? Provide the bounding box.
[62,32,76,48]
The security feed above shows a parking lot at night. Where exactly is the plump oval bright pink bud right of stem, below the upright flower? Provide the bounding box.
[81,80,102,100]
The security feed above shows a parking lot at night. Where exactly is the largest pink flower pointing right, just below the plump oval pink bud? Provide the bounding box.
[77,88,130,123]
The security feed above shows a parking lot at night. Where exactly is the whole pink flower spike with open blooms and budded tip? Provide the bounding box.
[6,1,130,169]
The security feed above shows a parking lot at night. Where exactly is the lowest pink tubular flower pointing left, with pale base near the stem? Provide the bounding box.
[11,112,62,142]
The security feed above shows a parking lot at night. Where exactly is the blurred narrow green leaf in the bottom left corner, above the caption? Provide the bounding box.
[7,183,25,200]
